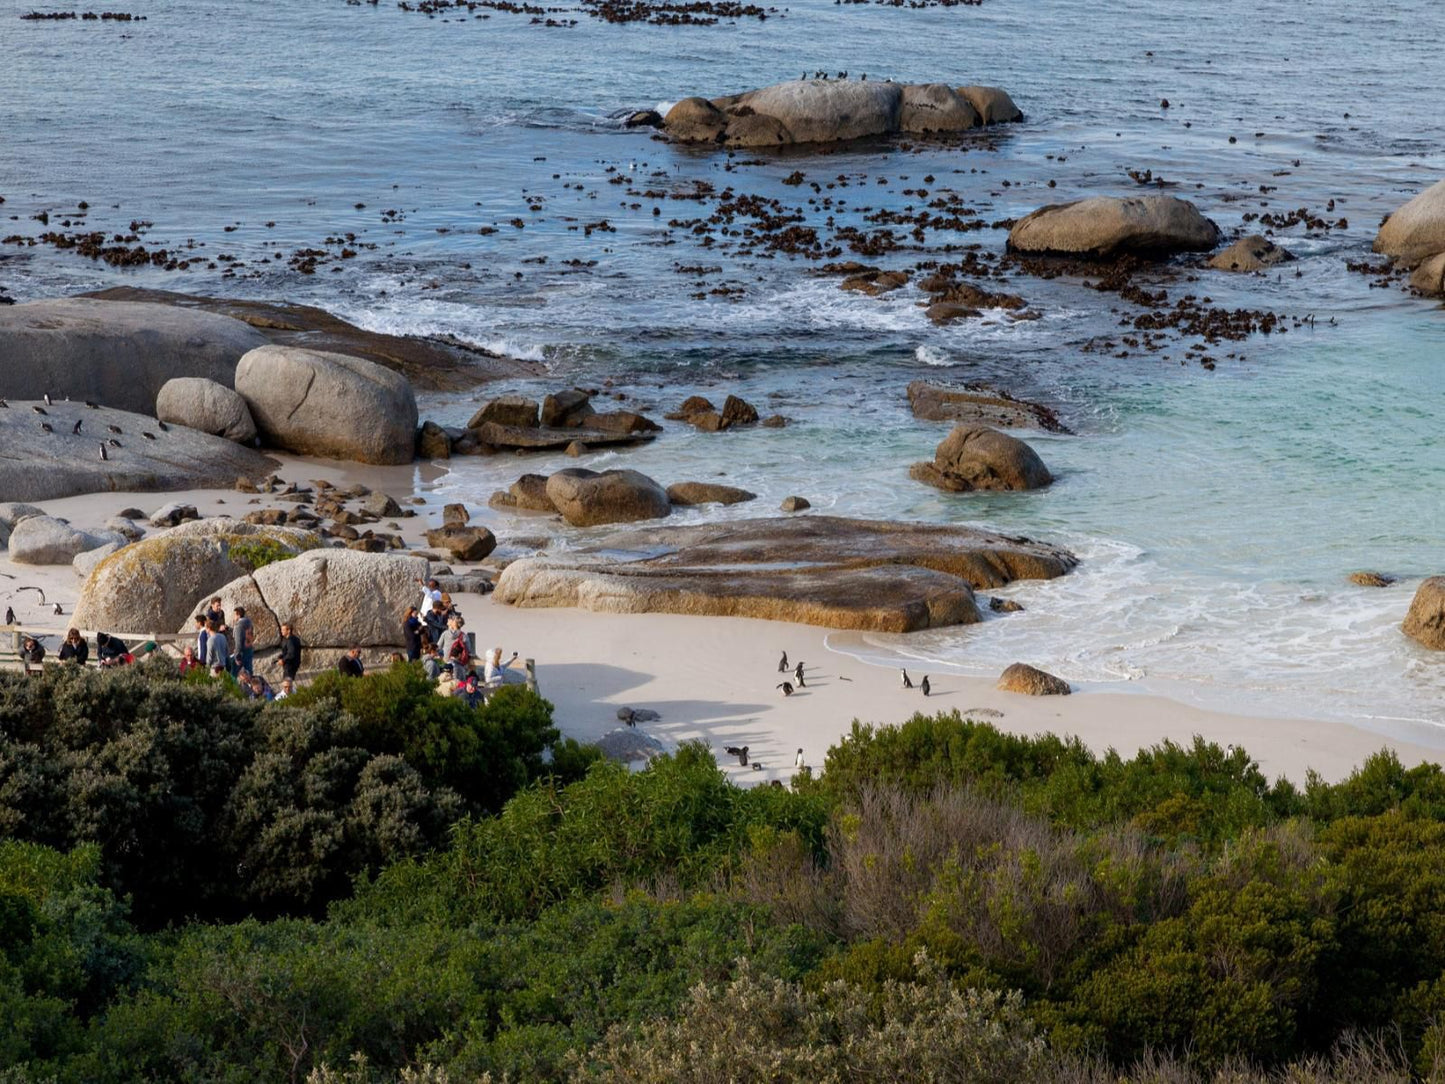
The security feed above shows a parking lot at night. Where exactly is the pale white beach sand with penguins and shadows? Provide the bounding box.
[0,457,1445,783]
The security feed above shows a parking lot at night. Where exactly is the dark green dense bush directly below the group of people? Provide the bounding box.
[0,662,563,926]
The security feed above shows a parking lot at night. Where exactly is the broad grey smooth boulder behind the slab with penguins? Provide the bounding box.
[0,298,266,415]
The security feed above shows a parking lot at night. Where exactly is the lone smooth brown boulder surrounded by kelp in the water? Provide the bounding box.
[1009,195,1220,259]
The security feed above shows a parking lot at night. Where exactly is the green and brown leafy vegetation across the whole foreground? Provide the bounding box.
[0,682,1445,1084]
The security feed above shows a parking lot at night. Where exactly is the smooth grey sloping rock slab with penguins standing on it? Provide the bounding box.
[0,399,280,500]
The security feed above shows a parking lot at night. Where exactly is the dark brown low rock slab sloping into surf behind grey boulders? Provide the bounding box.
[77,286,542,392]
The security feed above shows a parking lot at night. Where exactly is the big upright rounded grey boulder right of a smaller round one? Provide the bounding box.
[236,347,416,464]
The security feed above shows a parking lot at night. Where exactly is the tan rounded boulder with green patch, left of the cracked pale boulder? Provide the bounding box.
[72,519,321,633]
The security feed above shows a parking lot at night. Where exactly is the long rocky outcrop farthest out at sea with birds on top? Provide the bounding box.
[662,79,1023,147]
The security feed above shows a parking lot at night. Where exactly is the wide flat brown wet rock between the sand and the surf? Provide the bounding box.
[496,516,1075,632]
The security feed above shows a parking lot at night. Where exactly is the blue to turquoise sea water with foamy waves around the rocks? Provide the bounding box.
[0,0,1445,728]
